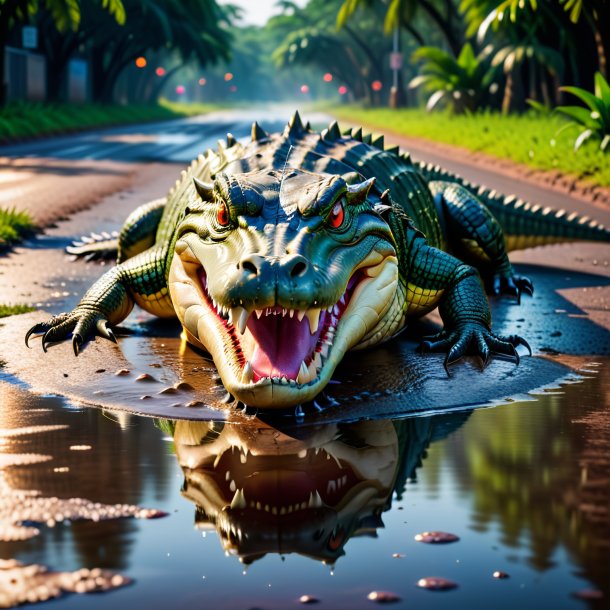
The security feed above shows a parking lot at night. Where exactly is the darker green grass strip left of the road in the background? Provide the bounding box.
[0,100,217,142]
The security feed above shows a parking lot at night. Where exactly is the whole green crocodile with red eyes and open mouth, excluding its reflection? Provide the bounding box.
[25,112,610,409]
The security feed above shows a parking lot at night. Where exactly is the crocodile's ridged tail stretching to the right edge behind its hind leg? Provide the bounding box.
[416,162,610,251]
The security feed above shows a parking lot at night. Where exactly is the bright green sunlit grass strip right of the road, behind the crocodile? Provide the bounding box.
[326,106,610,186]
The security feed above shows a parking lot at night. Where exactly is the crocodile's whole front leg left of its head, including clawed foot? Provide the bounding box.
[25,248,173,355]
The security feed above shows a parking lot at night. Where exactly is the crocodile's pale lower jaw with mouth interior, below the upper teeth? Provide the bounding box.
[169,240,396,408]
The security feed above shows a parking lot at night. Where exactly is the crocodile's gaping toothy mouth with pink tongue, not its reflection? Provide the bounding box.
[198,267,364,387]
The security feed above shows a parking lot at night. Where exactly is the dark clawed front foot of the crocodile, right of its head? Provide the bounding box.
[418,323,532,375]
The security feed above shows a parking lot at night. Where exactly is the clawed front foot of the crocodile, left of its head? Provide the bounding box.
[25,308,117,356]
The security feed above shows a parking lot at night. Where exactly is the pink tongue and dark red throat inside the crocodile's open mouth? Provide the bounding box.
[248,312,324,379]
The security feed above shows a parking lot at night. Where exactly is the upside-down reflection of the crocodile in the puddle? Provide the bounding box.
[166,415,467,564]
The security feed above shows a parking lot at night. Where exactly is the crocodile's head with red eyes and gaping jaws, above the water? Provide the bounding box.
[169,168,398,408]
